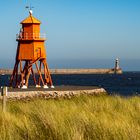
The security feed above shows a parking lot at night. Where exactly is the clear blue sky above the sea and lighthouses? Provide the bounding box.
[0,0,140,71]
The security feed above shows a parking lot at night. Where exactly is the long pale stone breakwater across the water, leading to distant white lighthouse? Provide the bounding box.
[0,69,122,74]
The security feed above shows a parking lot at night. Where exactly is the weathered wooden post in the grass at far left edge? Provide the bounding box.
[1,87,7,112]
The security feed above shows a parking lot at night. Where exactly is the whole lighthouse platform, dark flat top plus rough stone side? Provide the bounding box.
[0,86,106,100]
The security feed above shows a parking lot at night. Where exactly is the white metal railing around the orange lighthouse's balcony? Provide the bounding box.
[16,32,46,39]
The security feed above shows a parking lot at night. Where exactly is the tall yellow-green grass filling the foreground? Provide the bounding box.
[0,96,140,140]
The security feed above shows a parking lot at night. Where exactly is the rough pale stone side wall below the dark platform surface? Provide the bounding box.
[0,88,106,100]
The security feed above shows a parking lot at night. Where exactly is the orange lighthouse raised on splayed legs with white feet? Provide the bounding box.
[10,10,54,88]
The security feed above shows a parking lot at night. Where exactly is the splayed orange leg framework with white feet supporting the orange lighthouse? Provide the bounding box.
[10,58,54,88]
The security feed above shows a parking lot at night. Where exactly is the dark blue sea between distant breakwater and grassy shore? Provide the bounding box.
[0,72,140,96]
